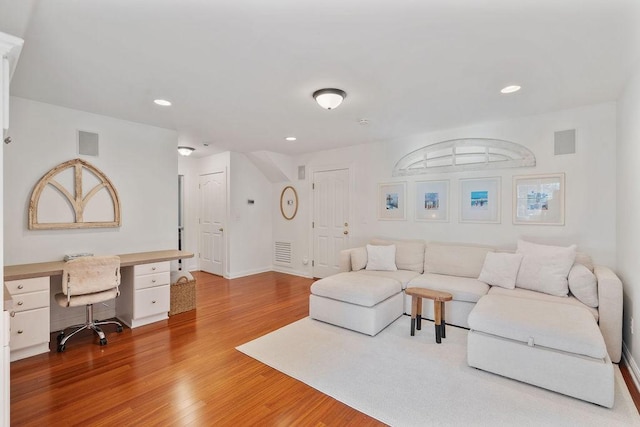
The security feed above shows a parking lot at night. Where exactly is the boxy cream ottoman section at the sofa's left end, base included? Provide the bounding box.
[309,273,404,336]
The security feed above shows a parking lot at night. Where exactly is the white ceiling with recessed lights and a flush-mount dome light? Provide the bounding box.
[0,0,640,155]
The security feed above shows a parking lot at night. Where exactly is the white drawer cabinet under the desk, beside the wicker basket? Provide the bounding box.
[116,261,171,328]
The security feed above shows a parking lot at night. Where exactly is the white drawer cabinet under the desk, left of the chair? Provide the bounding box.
[5,276,49,362]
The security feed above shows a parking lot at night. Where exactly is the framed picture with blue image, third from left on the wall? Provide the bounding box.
[460,177,501,224]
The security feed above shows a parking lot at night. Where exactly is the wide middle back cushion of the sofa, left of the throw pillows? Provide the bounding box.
[424,243,495,279]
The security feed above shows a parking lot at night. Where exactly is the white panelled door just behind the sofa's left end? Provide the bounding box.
[313,169,349,277]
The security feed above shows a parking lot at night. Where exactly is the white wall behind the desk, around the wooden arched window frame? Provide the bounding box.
[4,97,178,265]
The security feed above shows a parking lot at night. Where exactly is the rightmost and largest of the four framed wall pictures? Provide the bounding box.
[513,173,564,225]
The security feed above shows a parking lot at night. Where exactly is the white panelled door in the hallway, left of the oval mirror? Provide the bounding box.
[198,172,227,276]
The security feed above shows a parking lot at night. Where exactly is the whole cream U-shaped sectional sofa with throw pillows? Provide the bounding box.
[309,239,622,407]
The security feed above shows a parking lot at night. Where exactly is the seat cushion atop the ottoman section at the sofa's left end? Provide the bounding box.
[311,272,402,307]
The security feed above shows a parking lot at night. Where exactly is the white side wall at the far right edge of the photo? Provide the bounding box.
[616,66,640,378]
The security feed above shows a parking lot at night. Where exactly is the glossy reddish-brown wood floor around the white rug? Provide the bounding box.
[11,272,640,426]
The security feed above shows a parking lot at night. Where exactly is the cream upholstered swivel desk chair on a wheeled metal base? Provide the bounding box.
[55,256,122,352]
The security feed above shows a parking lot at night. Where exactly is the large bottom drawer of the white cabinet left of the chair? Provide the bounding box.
[9,307,49,351]
